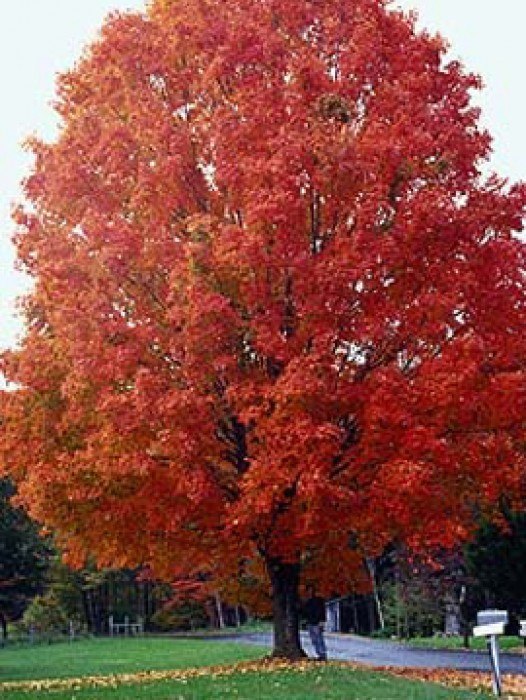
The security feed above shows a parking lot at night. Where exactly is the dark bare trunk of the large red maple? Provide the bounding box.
[266,557,306,660]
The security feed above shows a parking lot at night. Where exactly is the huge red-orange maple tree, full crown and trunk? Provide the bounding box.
[0,0,526,657]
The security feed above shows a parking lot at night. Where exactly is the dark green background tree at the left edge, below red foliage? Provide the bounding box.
[0,479,51,639]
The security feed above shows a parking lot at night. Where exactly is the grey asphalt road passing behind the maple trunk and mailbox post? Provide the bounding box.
[221,633,526,675]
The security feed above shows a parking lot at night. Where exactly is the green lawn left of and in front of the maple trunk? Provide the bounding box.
[0,639,496,700]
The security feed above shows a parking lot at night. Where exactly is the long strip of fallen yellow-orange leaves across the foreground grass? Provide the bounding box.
[0,659,526,698]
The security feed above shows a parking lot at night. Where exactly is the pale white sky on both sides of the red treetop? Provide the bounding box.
[0,0,526,349]
